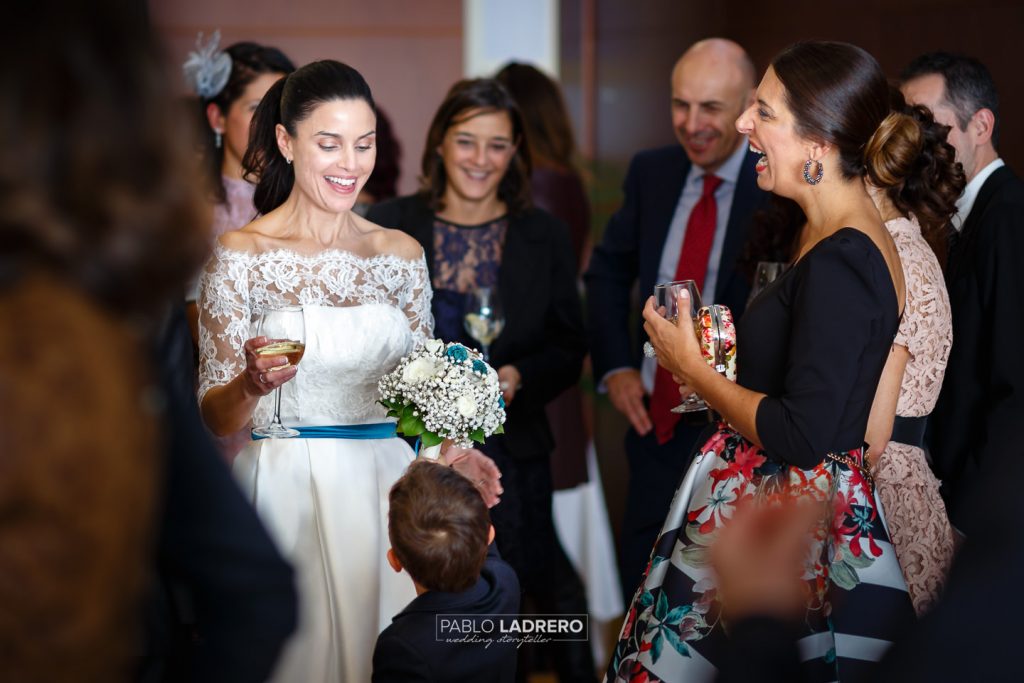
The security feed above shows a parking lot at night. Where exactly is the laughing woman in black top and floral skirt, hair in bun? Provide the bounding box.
[608,42,916,682]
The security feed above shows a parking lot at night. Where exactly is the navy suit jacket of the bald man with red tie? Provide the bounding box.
[584,144,768,379]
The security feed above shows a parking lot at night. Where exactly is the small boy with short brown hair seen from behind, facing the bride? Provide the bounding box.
[373,461,519,683]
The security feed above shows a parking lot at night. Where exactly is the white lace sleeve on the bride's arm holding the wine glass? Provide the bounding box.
[199,247,251,403]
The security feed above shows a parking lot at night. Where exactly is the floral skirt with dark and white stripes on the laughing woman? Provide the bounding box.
[607,424,914,683]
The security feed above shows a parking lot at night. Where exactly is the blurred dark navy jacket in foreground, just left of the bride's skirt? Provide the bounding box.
[136,307,296,683]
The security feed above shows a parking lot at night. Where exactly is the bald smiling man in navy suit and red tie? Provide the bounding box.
[585,39,767,603]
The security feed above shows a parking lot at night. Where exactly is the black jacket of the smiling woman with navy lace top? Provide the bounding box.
[368,195,587,458]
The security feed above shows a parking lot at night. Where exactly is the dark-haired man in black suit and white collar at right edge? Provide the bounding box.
[901,52,1024,533]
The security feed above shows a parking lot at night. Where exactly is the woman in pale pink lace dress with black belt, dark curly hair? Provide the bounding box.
[866,98,964,615]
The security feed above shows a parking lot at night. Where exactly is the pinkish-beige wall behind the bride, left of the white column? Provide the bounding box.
[150,0,462,193]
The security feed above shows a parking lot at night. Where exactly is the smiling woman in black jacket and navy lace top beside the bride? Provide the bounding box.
[368,79,595,681]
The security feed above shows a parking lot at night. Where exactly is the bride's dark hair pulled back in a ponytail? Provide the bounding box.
[242,59,376,214]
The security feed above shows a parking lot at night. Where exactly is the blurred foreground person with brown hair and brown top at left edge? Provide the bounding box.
[0,2,226,681]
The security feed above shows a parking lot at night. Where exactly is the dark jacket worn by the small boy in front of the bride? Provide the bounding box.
[373,544,519,683]
